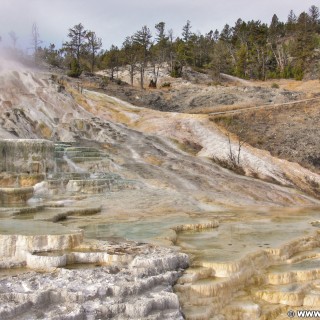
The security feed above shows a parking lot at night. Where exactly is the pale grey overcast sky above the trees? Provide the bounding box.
[0,0,320,49]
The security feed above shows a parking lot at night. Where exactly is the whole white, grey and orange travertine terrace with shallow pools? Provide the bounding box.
[0,61,320,320]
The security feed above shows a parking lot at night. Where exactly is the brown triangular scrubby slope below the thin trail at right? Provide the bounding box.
[212,101,320,173]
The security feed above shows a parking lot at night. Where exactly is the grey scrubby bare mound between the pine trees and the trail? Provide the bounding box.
[83,72,305,113]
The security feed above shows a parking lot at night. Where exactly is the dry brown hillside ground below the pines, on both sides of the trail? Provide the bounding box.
[88,73,320,173]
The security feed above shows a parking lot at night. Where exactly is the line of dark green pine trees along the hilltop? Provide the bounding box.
[28,6,320,88]
